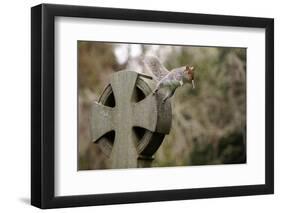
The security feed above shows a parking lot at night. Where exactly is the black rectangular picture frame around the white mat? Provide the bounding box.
[31,4,274,209]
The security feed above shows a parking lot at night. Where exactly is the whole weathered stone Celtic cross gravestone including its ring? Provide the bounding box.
[90,71,172,168]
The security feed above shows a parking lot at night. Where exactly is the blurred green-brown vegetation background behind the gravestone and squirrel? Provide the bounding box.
[78,41,246,170]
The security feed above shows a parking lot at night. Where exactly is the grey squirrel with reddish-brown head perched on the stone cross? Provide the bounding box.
[143,56,195,103]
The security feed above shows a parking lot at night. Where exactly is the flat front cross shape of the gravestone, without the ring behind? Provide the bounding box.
[91,71,171,168]
